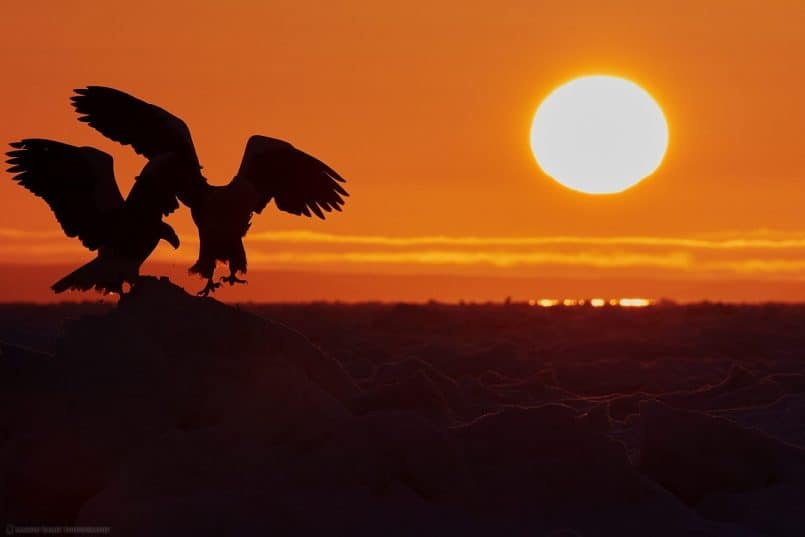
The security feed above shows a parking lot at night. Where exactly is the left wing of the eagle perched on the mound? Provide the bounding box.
[6,139,123,250]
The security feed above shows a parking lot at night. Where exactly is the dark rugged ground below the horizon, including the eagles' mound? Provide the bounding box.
[0,279,805,536]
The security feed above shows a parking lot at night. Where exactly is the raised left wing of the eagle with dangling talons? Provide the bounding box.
[70,86,199,169]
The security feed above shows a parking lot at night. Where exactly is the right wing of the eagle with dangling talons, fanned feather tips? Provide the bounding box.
[235,135,349,219]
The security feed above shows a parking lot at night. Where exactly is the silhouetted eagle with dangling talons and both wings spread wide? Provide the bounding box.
[71,86,349,296]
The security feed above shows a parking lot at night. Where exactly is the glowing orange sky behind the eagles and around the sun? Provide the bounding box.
[0,0,805,300]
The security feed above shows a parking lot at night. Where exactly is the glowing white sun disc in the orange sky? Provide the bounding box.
[531,75,668,194]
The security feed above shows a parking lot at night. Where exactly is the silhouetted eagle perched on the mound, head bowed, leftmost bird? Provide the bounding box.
[6,138,179,294]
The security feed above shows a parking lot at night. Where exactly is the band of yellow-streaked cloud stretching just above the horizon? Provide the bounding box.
[0,228,805,278]
